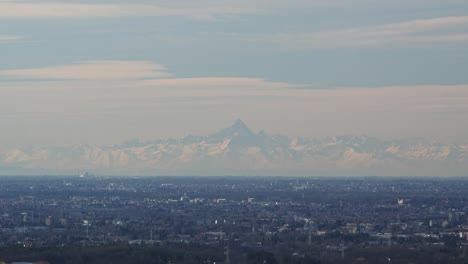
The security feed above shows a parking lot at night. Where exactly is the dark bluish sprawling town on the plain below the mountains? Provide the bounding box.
[0,173,468,264]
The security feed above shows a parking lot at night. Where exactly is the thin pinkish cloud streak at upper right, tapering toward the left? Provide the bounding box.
[250,16,468,49]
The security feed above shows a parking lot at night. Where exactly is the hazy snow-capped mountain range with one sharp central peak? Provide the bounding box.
[0,119,468,176]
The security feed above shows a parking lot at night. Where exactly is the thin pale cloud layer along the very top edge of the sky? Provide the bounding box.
[0,0,463,20]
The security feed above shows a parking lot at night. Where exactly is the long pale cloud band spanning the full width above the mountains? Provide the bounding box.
[0,61,468,111]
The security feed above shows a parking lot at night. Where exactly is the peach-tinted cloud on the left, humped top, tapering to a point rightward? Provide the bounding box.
[0,61,298,89]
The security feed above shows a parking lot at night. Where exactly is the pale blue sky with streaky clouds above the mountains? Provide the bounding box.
[0,0,468,150]
